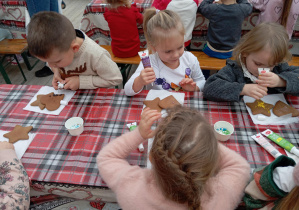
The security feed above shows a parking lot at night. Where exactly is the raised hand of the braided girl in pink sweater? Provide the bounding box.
[138,108,161,139]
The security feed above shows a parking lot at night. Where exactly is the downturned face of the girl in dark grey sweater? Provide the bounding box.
[244,47,274,77]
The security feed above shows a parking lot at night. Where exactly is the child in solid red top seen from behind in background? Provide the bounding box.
[104,0,143,58]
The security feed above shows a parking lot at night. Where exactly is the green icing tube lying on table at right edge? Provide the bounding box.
[262,129,299,157]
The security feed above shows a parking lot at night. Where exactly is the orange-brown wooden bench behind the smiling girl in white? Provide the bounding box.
[101,45,299,81]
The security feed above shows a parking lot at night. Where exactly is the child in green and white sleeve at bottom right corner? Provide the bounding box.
[240,155,299,210]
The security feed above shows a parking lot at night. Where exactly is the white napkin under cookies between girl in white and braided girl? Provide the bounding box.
[143,90,185,168]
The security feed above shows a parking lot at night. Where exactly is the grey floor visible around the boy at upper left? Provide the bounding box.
[0,0,91,86]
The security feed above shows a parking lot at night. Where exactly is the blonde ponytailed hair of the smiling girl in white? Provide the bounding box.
[143,7,185,48]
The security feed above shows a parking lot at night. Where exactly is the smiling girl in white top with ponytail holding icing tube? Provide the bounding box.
[125,8,205,96]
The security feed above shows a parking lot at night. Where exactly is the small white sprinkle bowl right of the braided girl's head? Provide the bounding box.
[214,121,234,141]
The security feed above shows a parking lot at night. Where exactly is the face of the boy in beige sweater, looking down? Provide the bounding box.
[38,48,74,68]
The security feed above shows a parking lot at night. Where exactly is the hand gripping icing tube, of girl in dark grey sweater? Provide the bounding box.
[256,72,286,88]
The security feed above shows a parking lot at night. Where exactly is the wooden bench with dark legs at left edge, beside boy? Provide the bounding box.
[0,39,39,84]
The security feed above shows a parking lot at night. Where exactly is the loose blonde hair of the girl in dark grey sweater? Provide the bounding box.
[234,23,291,65]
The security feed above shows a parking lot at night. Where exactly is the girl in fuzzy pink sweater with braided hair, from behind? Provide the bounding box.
[97,106,250,210]
